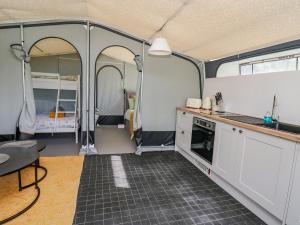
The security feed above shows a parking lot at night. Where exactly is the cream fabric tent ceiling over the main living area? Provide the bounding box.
[0,0,300,60]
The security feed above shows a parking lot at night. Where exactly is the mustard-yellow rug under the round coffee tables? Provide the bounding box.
[0,156,84,225]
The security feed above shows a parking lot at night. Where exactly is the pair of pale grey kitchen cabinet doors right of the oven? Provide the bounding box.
[213,123,300,220]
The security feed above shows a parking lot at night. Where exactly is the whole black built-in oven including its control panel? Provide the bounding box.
[191,117,216,164]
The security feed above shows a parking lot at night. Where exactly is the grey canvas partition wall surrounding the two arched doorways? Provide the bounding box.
[0,22,200,145]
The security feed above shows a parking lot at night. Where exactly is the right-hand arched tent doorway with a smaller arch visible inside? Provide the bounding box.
[95,46,140,154]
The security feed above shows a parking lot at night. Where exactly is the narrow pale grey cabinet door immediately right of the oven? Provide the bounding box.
[212,123,237,184]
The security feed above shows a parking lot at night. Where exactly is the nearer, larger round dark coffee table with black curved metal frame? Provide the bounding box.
[0,147,40,224]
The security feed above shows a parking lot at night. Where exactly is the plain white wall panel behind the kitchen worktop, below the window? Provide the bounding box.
[203,71,300,125]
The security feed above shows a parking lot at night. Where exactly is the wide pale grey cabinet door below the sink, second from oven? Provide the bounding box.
[237,130,296,219]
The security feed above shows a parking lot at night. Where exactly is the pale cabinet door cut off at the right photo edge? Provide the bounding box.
[286,144,300,225]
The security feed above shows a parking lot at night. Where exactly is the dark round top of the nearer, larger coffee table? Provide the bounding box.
[0,147,39,176]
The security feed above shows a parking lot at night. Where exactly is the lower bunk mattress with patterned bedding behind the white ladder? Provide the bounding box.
[36,114,76,131]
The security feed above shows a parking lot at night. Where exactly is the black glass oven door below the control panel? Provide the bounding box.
[191,124,215,164]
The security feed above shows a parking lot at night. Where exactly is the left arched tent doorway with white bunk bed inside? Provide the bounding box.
[29,37,82,154]
